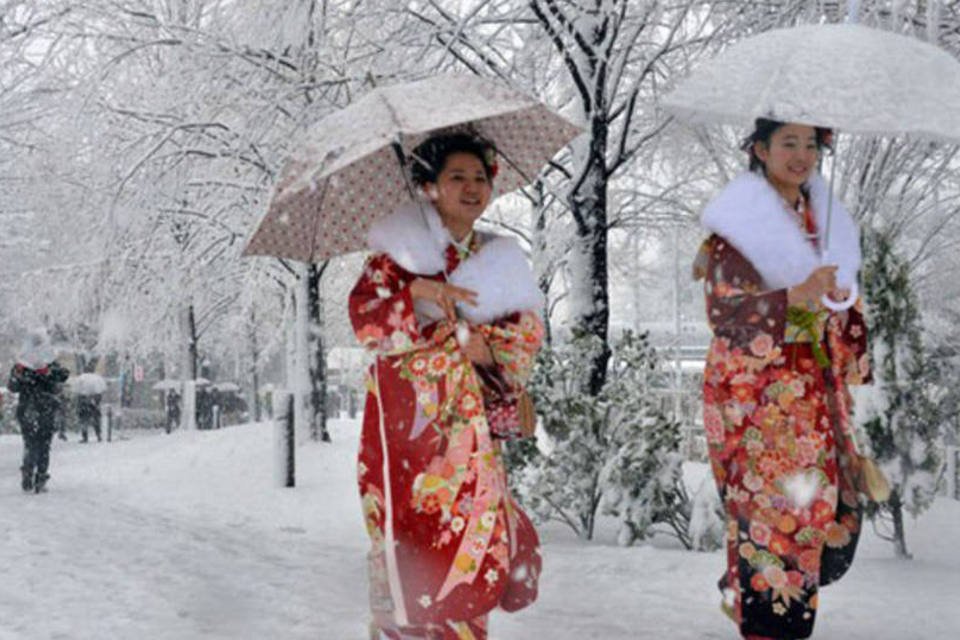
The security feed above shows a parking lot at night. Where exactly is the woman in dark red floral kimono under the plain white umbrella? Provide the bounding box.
[695,120,869,639]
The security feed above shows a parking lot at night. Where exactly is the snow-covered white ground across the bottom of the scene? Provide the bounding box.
[0,422,960,640]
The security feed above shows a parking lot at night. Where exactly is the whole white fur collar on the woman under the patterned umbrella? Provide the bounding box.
[367,202,543,324]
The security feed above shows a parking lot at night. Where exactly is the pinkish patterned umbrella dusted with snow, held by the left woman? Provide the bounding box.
[244,75,582,262]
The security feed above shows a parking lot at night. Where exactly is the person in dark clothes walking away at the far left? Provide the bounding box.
[7,330,70,493]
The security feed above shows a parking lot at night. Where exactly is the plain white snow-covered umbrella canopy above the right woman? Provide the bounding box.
[663,24,960,142]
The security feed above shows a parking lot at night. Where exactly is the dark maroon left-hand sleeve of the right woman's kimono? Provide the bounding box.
[694,235,787,349]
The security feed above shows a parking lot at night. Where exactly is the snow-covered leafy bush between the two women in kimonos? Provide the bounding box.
[508,333,690,546]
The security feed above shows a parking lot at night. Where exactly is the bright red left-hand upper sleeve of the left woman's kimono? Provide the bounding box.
[348,253,421,355]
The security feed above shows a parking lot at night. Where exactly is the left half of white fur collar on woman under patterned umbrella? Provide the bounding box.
[367,201,453,276]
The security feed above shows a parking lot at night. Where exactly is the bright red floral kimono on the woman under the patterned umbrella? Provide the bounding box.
[349,249,543,640]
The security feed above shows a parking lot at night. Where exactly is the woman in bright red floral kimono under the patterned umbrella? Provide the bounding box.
[349,134,543,640]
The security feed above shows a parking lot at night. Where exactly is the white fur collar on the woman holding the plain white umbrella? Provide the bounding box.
[701,172,861,289]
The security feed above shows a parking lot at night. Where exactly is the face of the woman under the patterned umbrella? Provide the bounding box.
[424,152,493,233]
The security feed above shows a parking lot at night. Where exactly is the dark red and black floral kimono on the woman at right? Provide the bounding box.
[695,235,870,638]
